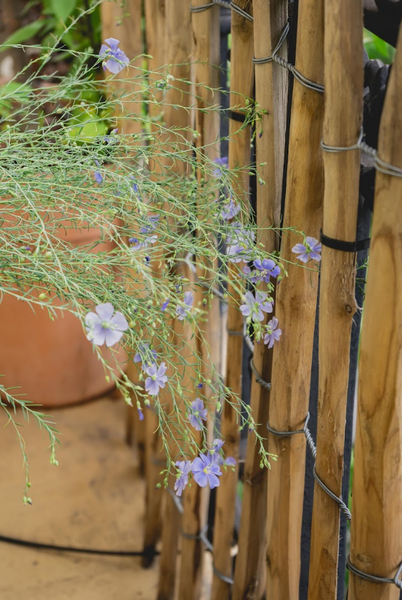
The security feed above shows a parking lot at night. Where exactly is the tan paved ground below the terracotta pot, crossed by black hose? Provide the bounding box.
[0,399,157,600]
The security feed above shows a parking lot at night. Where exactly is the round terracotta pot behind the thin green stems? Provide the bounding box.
[0,229,126,406]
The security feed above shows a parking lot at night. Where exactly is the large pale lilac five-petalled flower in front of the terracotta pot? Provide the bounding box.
[85,302,128,346]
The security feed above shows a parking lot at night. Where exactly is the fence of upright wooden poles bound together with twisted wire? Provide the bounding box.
[102,0,402,600]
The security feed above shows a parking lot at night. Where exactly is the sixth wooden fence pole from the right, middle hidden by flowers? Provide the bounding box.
[179,0,220,600]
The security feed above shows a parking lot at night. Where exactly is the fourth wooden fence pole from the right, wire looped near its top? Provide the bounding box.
[233,0,287,600]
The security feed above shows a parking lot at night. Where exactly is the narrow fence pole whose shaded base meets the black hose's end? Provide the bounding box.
[142,0,166,567]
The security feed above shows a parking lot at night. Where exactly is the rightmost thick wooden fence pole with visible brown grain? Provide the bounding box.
[349,23,402,600]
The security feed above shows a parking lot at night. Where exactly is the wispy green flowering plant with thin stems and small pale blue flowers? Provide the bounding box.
[0,4,286,502]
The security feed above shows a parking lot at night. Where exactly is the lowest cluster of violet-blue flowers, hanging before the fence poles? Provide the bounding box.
[174,439,236,496]
